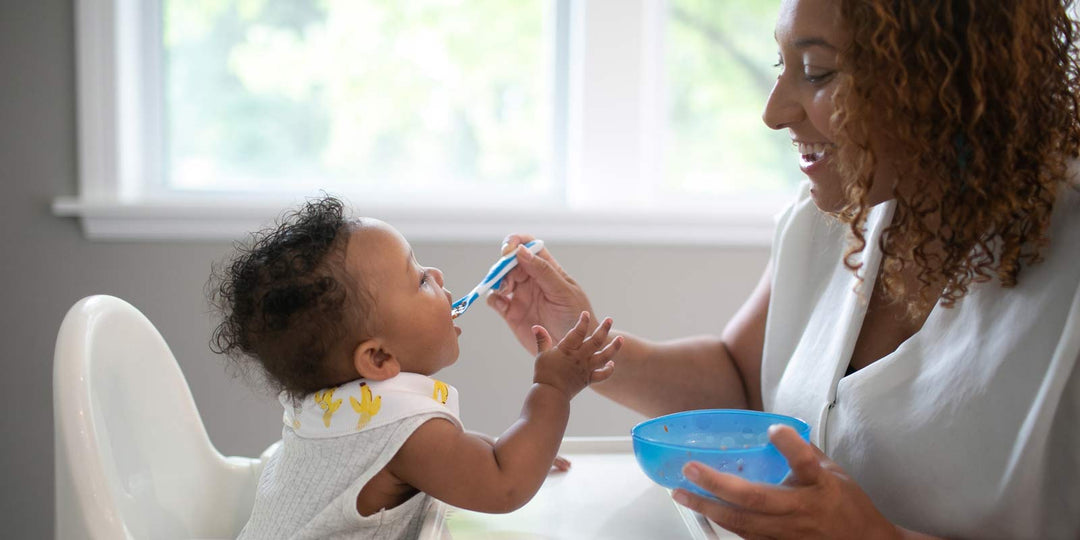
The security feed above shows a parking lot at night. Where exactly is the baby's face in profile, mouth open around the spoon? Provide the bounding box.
[346,218,461,375]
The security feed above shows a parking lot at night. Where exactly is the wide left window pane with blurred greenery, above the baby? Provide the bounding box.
[163,0,552,200]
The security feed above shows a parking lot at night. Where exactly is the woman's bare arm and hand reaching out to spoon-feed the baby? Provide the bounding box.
[488,234,771,416]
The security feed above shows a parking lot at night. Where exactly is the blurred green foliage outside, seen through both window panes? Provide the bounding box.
[164,0,797,197]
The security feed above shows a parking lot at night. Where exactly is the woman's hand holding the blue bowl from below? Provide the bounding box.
[673,426,903,539]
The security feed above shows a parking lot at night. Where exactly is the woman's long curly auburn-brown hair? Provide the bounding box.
[832,0,1080,318]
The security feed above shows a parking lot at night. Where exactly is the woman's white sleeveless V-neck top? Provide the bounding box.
[761,184,1080,538]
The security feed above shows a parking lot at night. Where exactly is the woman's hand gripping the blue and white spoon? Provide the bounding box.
[487,234,596,354]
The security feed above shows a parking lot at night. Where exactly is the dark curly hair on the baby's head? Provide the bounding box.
[207,197,370,400]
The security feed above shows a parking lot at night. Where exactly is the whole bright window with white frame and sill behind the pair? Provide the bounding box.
[54,0,797,244]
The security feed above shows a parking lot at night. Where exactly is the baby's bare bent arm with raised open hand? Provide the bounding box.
[387,313,622,513]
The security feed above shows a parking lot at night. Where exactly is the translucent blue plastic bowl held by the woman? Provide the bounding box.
[631,409,810,497]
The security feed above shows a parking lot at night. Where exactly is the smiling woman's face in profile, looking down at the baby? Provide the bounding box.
[761,0,848,211]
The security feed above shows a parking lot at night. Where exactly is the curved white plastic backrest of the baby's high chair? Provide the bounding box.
[53,296,276,539]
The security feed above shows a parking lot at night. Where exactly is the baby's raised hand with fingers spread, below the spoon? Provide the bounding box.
[532,311,622,399]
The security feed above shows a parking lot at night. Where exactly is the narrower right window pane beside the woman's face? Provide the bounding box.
[663,0,800,197]
